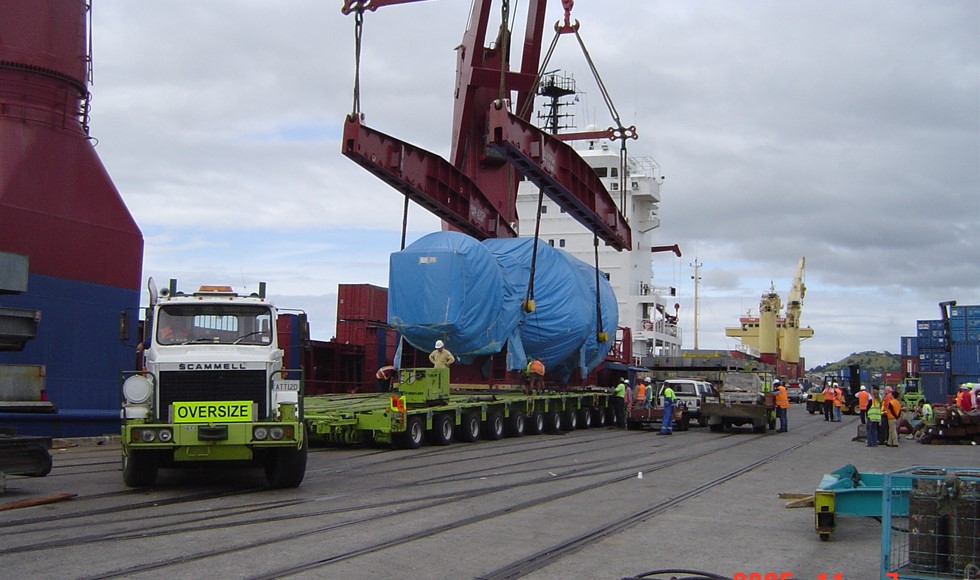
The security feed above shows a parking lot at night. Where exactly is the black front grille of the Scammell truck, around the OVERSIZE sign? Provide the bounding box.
[157,370,269,419]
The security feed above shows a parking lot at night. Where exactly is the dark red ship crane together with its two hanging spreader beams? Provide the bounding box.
[342,0,635,250]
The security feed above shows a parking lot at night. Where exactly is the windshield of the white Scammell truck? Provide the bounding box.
[157,304,273,345]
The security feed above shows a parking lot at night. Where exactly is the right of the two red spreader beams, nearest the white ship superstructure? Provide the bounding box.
[487,102,632,250]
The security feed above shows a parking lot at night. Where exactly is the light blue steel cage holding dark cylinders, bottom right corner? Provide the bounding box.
[880,466,980,580]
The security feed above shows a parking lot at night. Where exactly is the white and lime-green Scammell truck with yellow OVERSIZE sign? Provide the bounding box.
[122,279,307,487]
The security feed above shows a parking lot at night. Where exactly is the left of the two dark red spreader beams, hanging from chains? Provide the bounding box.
[343,115,517,240]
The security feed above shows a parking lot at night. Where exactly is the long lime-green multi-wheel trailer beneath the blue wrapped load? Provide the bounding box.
[303,369,613,448]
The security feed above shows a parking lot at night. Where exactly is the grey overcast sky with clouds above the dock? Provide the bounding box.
[91,0,980,366]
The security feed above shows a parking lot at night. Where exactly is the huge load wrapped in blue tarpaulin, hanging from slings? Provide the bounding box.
[388,232,618,377]
